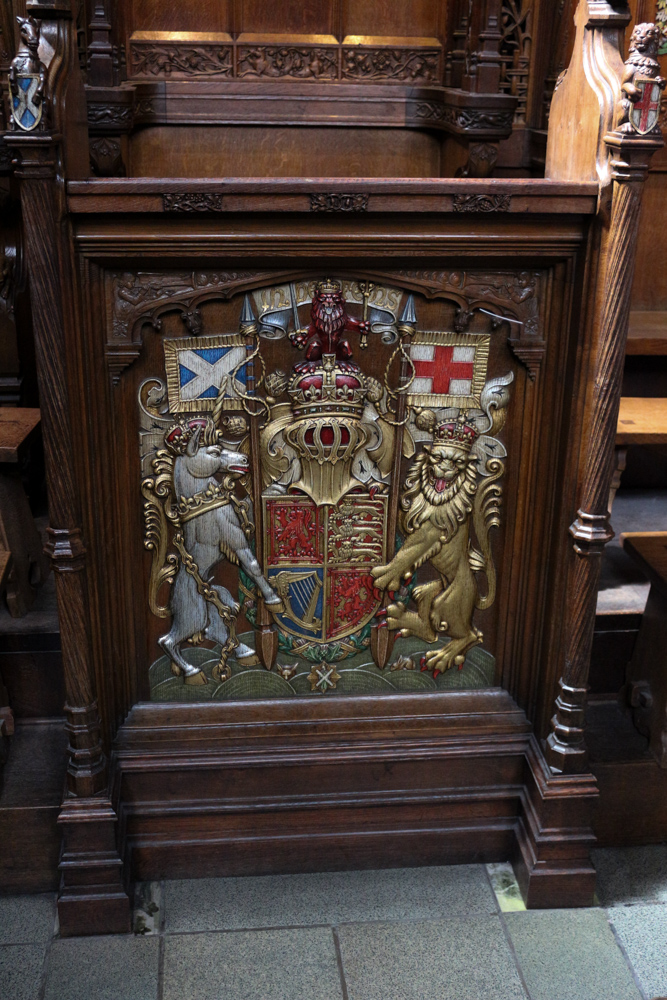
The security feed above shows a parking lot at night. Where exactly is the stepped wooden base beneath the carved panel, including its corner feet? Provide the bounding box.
[53,689,597,934]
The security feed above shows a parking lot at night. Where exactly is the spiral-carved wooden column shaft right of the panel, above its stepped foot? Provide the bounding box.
[547,132,662,773]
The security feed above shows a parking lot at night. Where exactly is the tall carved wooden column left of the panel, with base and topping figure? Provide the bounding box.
[7,0,129,934]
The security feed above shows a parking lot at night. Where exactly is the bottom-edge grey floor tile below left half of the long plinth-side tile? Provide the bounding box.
[163,927,342,1000]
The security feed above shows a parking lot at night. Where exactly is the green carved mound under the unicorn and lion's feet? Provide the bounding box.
[149,632,495,702]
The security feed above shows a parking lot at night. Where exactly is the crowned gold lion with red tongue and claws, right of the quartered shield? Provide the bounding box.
[372,373,513,677]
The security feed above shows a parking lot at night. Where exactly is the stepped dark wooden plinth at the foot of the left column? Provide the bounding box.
[58,797,132,937]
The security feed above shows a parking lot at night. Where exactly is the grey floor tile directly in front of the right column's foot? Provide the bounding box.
[504,910,641,1000]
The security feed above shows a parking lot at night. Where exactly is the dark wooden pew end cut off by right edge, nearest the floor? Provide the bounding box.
[621,531,667,767]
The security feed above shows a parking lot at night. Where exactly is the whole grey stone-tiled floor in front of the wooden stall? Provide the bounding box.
[0,845,667,1000]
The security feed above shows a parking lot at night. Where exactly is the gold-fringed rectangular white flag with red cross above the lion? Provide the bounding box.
[408,330,490,407]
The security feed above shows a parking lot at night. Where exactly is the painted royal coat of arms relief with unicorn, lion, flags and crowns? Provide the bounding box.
[139,279,513,697]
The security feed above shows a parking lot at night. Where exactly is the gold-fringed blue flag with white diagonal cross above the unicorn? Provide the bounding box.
[164,335,246,413]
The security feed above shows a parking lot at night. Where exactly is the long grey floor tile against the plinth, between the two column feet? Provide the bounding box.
[165,865,495,933]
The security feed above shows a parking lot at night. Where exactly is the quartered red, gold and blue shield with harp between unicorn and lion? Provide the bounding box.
[263,491,387,644]
